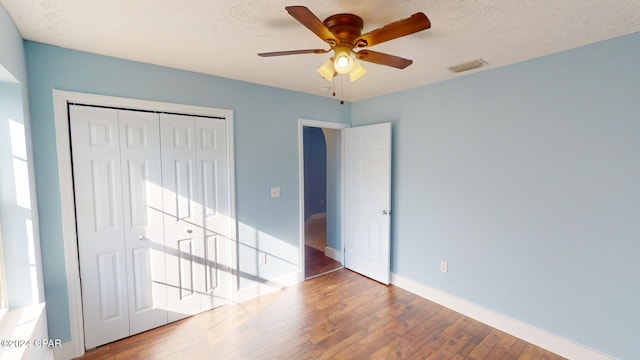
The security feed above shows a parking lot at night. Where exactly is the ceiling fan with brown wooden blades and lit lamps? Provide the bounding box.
[258,6,431,82]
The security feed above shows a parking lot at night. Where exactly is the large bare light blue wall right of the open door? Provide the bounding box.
[352,33,640,359]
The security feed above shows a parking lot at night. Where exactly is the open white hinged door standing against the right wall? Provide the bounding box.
[343,123,391,284]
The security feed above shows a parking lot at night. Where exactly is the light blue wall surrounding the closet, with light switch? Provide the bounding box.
[25,41,350,341]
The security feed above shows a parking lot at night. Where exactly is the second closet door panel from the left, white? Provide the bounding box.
[114,110,168,335]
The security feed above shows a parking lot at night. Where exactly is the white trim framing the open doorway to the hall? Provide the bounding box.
[298,119,351,281]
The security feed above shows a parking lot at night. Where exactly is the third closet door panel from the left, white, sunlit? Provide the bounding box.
[160,114,207,321]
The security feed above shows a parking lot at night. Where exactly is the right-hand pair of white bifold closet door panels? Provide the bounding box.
[160,114,232,321]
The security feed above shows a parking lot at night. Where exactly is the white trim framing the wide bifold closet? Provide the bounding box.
[53,89,237,358]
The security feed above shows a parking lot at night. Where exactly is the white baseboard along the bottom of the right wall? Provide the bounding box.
[391,273,613,360]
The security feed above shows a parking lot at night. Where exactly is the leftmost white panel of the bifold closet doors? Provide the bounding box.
[69,106,129,348]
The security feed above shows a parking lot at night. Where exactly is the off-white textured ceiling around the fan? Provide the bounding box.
[0,0,640,100]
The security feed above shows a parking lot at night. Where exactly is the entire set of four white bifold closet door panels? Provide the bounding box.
[69,105,232,349]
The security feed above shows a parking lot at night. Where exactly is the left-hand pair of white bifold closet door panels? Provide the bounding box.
[69,106,167,348]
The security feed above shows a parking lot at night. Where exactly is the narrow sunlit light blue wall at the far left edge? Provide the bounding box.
[0,5,44,307]
